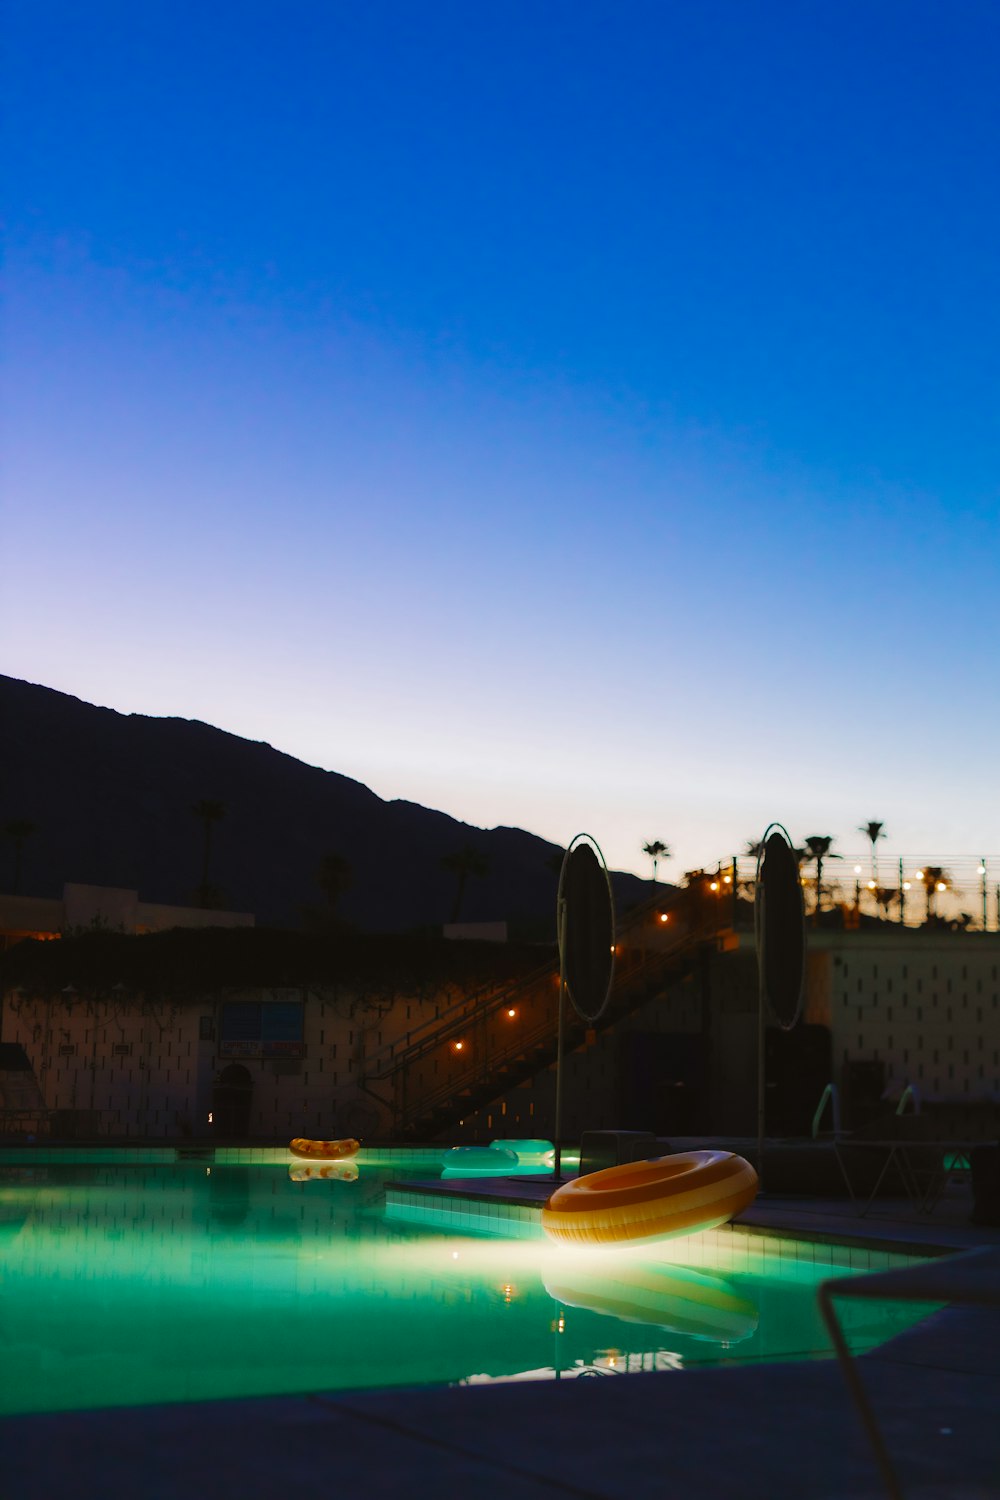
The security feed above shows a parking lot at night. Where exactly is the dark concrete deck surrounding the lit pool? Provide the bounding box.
[0,1178,1000,1500]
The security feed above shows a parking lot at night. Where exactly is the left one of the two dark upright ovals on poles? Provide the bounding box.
[559,834,615,1022]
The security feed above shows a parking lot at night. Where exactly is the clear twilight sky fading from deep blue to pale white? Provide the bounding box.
[0,0,1000,878]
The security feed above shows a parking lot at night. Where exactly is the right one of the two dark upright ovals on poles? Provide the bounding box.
[754,824,805,1031]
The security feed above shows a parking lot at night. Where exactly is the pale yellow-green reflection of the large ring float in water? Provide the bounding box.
[546,1263,757,1344]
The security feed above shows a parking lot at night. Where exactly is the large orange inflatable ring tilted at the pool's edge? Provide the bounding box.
[541,1151,757,1245]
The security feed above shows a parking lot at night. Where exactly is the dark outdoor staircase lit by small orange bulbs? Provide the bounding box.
[366,888,730,1140]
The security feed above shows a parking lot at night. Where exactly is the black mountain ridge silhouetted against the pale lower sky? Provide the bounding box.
[0,675,649,939]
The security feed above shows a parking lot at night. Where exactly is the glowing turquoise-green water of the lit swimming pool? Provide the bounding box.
[0,1163,941,1413]
